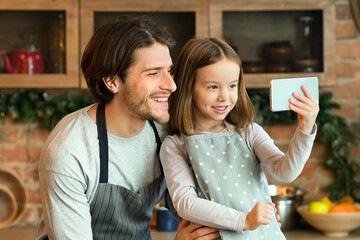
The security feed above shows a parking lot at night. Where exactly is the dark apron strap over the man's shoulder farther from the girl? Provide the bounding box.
[96,104,109,183]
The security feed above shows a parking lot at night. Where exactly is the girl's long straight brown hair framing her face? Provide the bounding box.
[168,38,255,136]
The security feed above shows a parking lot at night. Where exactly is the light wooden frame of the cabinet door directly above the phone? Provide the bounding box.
[209,0,336,88]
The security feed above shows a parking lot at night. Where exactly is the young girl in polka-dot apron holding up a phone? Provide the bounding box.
[160,39,319,240]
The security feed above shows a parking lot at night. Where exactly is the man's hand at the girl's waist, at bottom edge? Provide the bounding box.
[175,220,220,240]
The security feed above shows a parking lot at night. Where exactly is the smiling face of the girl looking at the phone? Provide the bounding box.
[194,58,240,132]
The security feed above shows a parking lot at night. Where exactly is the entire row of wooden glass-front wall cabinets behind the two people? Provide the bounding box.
[0,0,336,88]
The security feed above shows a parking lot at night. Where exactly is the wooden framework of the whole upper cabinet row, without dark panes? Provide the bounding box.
[0,0,336,88]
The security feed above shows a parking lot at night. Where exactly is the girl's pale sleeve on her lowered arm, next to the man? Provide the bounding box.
[160,136,247,232]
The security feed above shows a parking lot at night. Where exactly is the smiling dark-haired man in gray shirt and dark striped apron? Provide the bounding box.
[38,17,219,240]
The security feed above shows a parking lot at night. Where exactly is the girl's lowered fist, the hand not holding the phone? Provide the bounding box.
[244,202,275,230]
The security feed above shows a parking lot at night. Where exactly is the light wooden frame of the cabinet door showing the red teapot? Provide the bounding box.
[0,0,79,88]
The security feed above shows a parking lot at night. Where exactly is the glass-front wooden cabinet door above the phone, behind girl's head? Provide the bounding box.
[208,0,335,88]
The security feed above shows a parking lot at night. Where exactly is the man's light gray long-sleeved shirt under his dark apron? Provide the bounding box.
[38,105,163,239]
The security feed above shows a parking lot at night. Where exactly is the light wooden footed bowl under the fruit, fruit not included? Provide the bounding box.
[296,204,360,237]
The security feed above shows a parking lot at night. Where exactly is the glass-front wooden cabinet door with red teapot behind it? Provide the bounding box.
[0,0,80,88]
